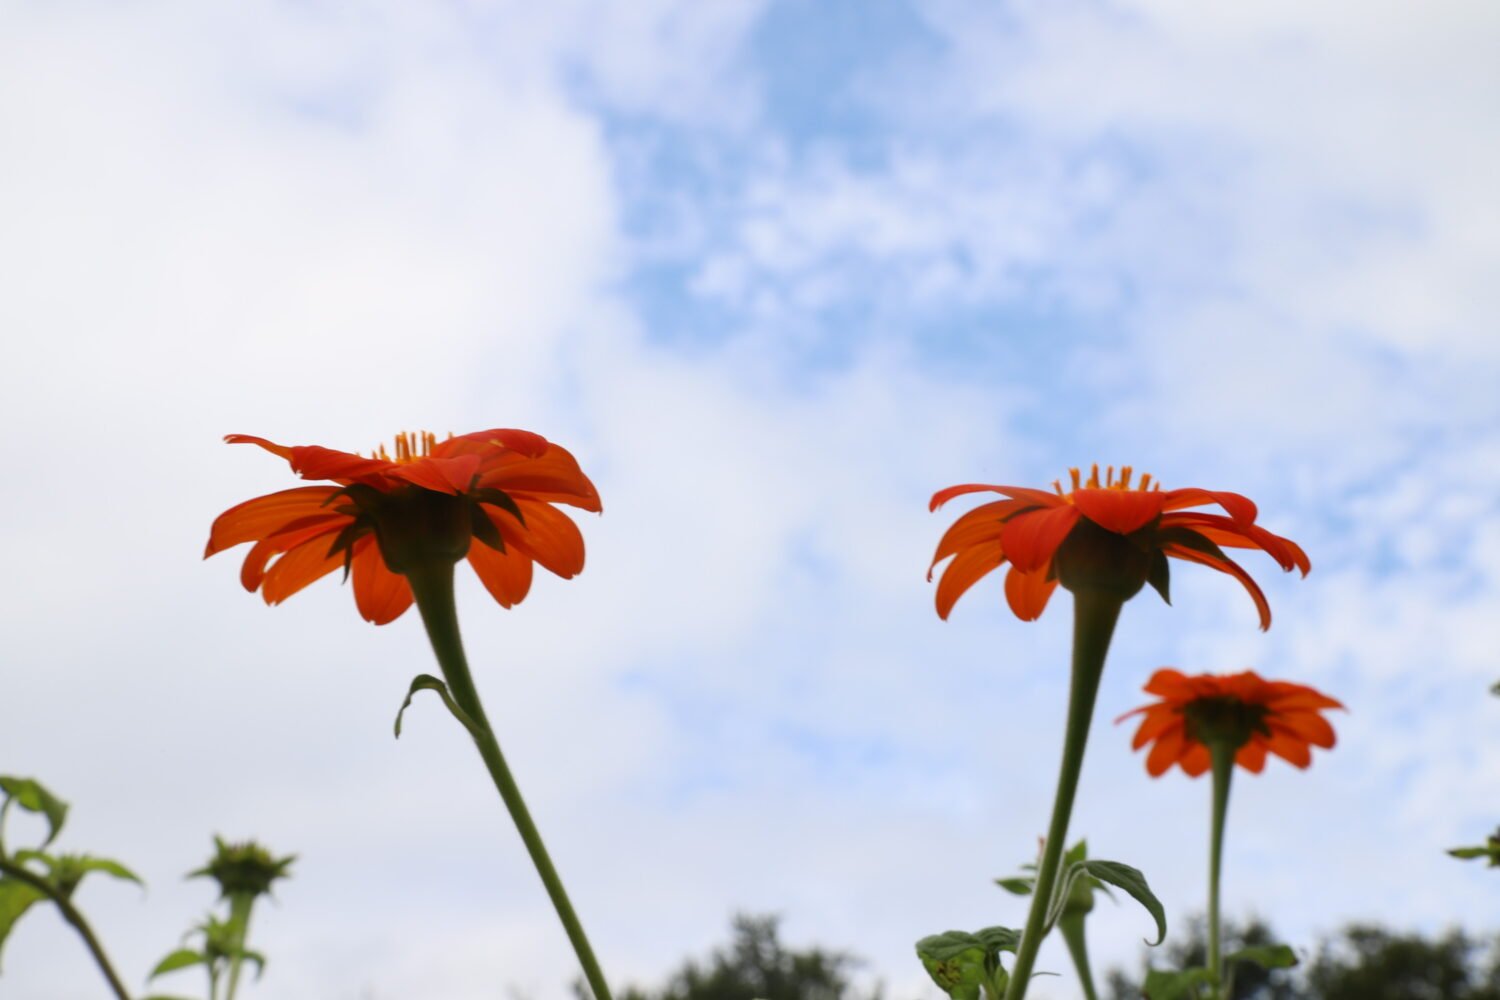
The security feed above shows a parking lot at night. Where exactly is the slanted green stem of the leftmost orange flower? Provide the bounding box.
[407,564,611,1000]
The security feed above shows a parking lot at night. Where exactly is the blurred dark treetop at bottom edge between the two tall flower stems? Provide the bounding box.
[606,915,881,1000]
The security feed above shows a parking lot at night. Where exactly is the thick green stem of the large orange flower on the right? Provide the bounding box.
[1005,589,1125,1000]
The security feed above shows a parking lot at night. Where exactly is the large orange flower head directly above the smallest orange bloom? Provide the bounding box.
[927,465,1310,628]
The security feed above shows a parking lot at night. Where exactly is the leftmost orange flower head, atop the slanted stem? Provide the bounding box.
[204,430,602,625]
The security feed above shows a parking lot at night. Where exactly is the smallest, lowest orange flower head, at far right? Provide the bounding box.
[1115,667,1344,778]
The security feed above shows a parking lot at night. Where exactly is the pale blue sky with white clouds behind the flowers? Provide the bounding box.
[0,0,1500,1000]
